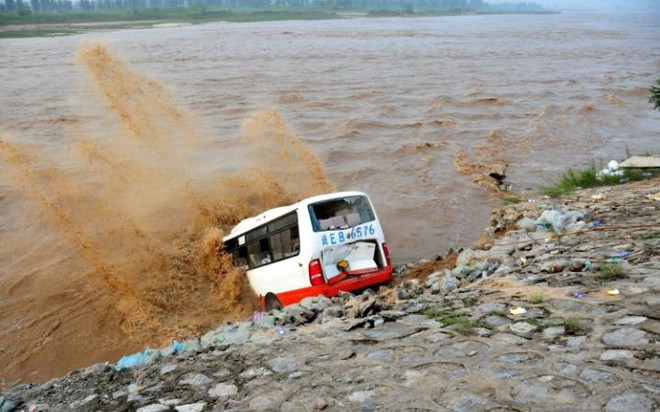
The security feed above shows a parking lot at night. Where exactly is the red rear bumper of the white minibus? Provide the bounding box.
[272,266,392,306]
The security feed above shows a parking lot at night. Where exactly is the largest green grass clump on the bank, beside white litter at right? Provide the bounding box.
[542,163,657,197]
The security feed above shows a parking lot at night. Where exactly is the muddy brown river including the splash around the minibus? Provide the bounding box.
[0,13,660,386]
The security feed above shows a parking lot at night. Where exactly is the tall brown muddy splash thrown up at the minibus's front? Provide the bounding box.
[0,44,333,380]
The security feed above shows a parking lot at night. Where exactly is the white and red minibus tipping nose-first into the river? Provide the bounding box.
[223,192,392,310]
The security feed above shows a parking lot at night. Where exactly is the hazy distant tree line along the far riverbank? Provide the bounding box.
[0,0,543,14]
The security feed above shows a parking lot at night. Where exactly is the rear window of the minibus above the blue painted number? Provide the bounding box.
[309,196,376,232]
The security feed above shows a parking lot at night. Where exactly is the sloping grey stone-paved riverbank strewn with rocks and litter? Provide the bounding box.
[0,179,660,412]
